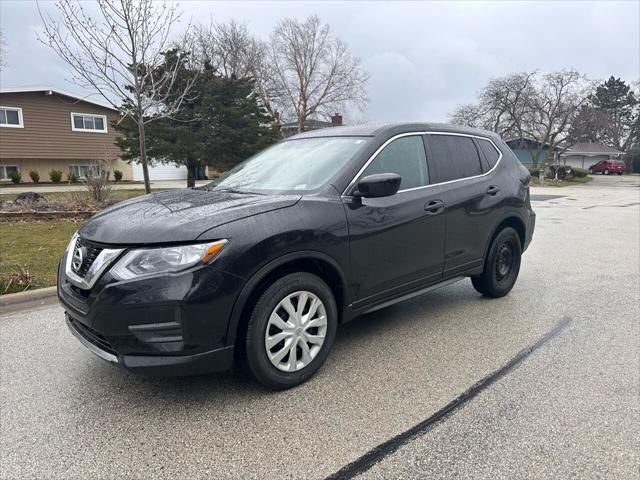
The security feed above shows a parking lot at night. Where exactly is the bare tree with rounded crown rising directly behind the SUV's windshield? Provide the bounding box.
[267,15,368,132]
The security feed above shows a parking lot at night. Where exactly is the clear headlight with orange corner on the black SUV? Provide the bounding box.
[111,240,227,280]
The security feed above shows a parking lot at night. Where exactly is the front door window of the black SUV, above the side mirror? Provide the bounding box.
[360,135,429,190]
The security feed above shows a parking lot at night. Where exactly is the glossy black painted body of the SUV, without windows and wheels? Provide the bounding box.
[58,124,535,374]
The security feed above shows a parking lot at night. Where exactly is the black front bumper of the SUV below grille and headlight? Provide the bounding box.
[58,249,241,376]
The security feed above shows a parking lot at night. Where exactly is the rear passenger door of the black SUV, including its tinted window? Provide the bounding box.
[426,133,505,277]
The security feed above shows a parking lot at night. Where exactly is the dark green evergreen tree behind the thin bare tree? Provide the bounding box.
[116,51,278,187]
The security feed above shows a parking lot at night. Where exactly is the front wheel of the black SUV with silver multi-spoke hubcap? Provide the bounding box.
[245,272,338,390]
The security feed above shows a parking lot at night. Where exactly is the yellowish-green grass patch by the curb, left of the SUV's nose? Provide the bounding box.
[0,220,81,294]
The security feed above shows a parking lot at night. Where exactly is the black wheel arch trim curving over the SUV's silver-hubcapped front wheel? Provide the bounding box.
[222,250,348,345]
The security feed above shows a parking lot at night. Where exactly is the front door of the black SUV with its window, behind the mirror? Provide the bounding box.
[345,134,445,307]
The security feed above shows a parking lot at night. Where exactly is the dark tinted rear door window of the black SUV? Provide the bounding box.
[427,135,482,182]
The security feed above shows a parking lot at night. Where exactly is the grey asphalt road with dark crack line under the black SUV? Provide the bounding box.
[0,176,640,479]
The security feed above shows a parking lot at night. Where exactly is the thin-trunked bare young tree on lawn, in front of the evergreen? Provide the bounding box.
[40,0,193,193]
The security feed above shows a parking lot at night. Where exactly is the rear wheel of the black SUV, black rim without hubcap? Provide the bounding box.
[471,227,522,298]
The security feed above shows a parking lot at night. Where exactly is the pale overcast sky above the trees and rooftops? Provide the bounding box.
[0,0,640,121]
